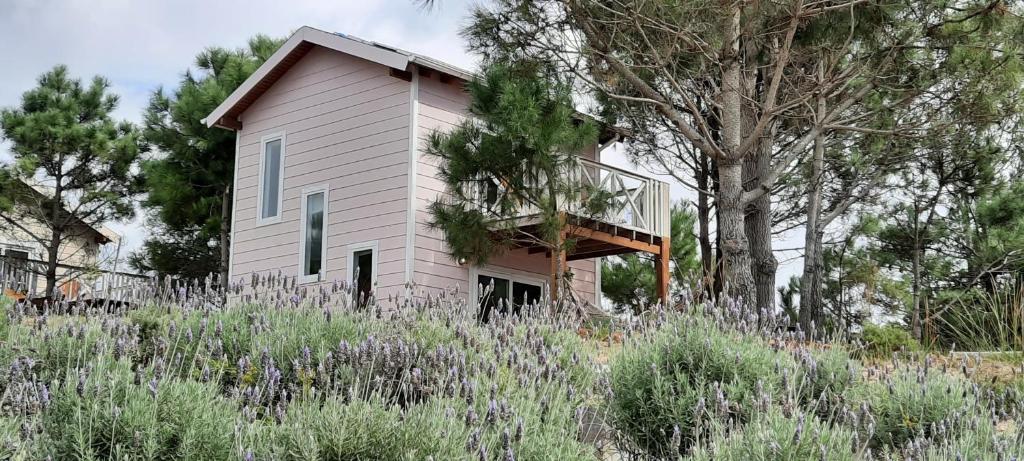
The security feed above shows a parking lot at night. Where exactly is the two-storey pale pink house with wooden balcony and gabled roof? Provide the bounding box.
[205,27,670,311]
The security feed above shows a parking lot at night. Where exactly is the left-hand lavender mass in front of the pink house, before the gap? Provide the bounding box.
[0,275,598,460]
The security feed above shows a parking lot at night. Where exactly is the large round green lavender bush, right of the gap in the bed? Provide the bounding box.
[609,317,798,456]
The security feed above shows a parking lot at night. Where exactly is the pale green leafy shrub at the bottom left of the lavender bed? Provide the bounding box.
[43,359,238,460]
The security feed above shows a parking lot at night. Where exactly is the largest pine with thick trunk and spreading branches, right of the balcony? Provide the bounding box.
[467,0,1024,323]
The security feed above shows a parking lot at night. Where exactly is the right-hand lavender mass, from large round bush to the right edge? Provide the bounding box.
[606,292,1024,460]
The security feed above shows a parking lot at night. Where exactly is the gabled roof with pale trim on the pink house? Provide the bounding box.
[203,26,473,130]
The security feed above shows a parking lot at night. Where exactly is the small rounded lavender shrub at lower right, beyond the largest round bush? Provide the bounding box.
[849,364,978,448]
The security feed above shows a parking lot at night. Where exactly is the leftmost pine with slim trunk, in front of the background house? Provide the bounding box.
[0,66,142,297]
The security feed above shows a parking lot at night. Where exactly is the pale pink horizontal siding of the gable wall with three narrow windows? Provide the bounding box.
[231,47,411,296]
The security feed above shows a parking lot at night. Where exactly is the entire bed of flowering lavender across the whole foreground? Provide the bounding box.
[0,276,1024,461]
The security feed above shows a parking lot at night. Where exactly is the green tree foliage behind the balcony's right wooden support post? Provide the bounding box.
[601,204,702,313]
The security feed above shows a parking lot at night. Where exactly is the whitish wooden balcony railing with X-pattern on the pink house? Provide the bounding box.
[467,158,671,237]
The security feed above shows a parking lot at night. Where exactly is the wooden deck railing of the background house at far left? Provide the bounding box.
[0,256,150,301]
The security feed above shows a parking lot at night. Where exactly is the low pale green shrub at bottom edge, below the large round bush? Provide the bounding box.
[691,408,861,461]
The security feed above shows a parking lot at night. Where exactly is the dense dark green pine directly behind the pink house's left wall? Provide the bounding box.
[132,36,283,281]
